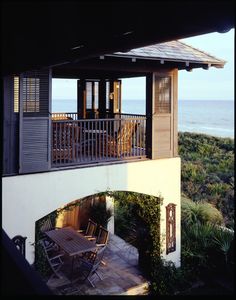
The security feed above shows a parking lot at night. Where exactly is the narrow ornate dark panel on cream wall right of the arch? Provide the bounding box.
[166,203,176,254]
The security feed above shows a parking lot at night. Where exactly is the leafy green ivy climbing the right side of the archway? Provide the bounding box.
[107,192,183,295]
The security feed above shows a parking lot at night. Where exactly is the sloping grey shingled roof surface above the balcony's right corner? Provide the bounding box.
[106,40,226,68]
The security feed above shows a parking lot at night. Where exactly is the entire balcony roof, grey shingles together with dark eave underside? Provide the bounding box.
[52,41,225,79]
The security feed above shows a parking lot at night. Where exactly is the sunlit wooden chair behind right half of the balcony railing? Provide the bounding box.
[99,120,137,157]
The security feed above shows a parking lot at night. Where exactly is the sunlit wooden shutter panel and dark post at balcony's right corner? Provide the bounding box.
[146,69,178,159]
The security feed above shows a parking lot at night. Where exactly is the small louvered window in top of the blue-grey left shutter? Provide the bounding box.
[23,77,40,112]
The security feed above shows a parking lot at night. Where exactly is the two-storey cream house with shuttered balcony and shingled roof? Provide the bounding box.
[2,41,225,266]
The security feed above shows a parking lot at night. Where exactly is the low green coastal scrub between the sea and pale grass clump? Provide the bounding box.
[179,132,234,228]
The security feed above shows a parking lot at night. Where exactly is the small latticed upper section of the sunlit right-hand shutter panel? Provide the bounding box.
[155,76,171,114]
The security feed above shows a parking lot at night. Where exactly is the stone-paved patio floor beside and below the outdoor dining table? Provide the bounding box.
[47,234,148,295]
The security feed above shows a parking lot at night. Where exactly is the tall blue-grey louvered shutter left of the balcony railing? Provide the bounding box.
[20,70,51,173]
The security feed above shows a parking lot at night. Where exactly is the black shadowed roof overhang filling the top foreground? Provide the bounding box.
[1,0,234,75]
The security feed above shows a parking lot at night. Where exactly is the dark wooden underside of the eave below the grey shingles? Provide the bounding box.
[52,55,223,78]
